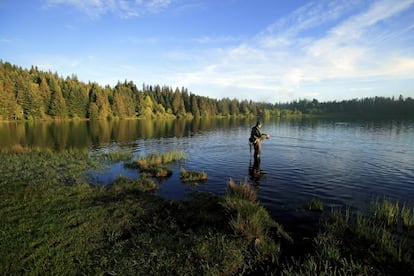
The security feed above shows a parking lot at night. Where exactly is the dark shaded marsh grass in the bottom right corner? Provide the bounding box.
[282,198,414,275]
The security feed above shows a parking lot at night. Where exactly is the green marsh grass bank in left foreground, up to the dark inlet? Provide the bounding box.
[0,150,292,275]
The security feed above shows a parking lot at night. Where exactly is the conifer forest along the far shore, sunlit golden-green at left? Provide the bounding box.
[0,60,414,121]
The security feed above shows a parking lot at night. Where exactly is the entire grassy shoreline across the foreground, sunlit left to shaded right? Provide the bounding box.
[0,149,414,275]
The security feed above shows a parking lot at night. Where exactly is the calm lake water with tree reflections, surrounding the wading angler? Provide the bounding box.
[0,119,414,232]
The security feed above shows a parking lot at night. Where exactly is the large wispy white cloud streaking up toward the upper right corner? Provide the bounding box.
[174,0,414,100]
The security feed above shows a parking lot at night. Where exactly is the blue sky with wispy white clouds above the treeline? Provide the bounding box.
[0,0,414,103]
